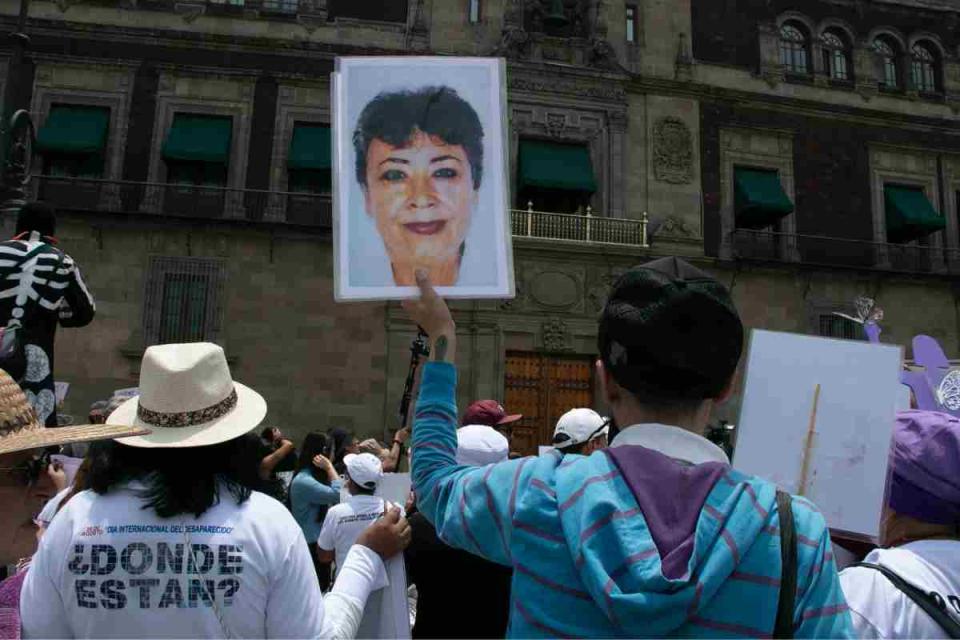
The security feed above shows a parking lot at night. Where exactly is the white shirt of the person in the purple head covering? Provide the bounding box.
[840,540,960,638]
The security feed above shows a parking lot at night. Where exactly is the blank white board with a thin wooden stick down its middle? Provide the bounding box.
[733,330,903,539]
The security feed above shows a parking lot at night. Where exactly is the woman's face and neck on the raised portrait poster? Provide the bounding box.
[364,130,478,285]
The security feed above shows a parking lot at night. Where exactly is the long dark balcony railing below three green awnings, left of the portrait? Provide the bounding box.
[31,176,332,228]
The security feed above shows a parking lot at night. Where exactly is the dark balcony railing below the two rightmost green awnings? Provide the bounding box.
[731,229,960,273]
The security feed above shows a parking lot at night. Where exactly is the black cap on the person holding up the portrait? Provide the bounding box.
[598,258,743,402]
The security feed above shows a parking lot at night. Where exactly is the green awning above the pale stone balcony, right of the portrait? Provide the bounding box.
[518,140,597,193]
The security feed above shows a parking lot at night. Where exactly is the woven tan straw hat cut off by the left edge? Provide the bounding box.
[0,369,149,454]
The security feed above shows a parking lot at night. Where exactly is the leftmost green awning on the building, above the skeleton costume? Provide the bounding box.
[37,104,110,154]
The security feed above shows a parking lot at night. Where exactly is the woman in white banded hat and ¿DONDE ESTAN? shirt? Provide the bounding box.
[20,343,410,638]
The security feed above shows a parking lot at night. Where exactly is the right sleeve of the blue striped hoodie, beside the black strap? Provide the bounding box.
[793,498,856,638]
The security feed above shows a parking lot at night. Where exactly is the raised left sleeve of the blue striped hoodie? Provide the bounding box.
[413,362,532,565]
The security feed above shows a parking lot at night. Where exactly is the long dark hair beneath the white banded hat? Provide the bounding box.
[87,435,265,518]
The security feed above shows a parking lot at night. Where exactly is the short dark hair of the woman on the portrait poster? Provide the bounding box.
[353,87,483,190]
